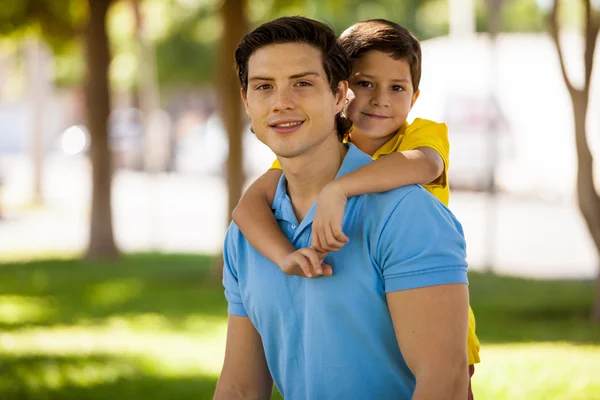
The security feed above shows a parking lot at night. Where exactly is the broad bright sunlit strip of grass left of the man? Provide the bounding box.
[0,316,226,376]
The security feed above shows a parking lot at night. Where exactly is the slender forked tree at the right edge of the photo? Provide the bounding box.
[548,0,600,323]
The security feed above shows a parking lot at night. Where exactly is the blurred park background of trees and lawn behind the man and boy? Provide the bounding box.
[0,0,600,400]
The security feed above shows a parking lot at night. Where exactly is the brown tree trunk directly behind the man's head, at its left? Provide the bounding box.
[216,0,248,276]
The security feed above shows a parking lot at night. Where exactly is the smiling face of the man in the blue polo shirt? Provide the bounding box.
[242,43,348,158]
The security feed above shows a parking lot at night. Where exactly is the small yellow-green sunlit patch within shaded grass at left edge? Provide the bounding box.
[0,295,54,325]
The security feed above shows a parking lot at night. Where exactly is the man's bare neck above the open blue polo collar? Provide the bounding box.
[280,135,348,222]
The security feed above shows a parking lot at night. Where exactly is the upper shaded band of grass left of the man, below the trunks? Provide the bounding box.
[0,254,227,331]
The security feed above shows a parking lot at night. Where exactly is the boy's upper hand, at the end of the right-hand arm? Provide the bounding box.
[312,181,350,252]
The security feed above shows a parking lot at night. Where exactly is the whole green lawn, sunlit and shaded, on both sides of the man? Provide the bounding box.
[0,254,600,400]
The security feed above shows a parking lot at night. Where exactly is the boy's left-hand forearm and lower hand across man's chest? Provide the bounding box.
[232,169,332,278]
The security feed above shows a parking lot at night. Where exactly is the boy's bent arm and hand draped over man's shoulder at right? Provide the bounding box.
[312,147,444,251]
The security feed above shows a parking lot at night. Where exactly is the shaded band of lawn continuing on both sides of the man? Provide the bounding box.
[0,254,600,344]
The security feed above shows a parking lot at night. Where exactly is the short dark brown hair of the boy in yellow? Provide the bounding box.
[340,19,421,92]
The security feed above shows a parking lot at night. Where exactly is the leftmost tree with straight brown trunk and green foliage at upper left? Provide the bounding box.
[0,0,119,258]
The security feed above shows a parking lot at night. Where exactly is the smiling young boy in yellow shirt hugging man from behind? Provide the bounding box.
[233,20,479,398]
